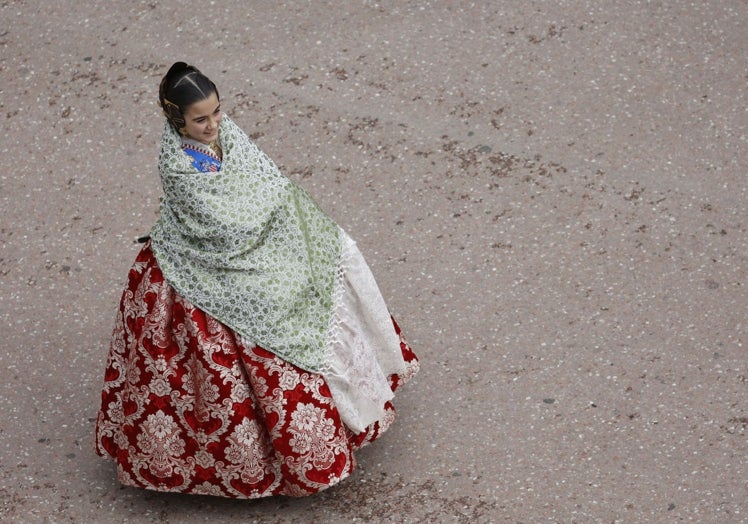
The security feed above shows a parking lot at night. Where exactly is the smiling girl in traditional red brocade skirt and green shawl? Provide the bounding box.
[96,62,418,498]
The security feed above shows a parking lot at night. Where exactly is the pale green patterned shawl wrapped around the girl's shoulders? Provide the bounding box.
[151,116,341,372]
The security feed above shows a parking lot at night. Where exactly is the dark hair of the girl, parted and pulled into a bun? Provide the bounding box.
[158,62,220,132]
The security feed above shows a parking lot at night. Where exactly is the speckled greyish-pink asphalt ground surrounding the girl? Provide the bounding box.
[0,0,748,523]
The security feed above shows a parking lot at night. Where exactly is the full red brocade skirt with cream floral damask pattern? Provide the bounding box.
[96,244,418,498]
